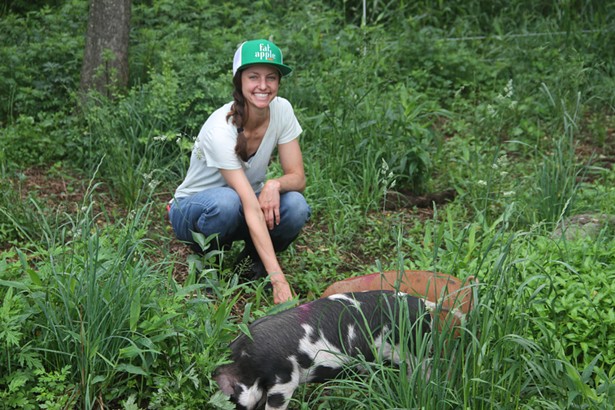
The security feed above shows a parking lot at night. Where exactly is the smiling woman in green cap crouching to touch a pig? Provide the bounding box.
[169,40,311,303]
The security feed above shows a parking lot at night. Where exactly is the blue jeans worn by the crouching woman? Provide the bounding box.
[169,187,312,252]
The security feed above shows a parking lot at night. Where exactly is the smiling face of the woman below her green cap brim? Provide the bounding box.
[241,64,280,109]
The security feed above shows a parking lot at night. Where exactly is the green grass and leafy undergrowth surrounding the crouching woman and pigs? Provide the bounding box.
[0,0,615,409]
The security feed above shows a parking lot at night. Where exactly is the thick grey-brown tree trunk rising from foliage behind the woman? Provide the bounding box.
[80,0,132,96]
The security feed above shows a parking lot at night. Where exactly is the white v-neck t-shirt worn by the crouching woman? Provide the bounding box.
[175,97,303,198]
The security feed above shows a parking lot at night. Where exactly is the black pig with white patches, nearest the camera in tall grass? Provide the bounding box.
[214,290,435,410]
